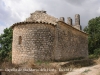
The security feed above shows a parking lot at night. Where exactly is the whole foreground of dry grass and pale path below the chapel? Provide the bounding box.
[0,59,100,75]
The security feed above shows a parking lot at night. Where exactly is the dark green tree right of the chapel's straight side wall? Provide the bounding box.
[84,16,100,54]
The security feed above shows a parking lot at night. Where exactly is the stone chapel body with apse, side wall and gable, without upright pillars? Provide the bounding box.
[12,11,88,64]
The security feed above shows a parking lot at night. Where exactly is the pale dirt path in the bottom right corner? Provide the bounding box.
[66,64,100,75]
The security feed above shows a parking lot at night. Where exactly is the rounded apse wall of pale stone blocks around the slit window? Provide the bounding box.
[12,23,55,64]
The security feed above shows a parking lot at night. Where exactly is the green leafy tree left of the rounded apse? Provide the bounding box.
[0,28,12,60]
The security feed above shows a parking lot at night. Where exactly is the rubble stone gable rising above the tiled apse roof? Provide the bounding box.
[26,11,58,24]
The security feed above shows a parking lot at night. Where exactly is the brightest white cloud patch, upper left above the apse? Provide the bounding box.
[3,0,40,20]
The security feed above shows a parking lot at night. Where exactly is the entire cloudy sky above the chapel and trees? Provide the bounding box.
[0,0,100,34]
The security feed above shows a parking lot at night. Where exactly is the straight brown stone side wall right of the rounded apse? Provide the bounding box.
[55,21,88,61]
